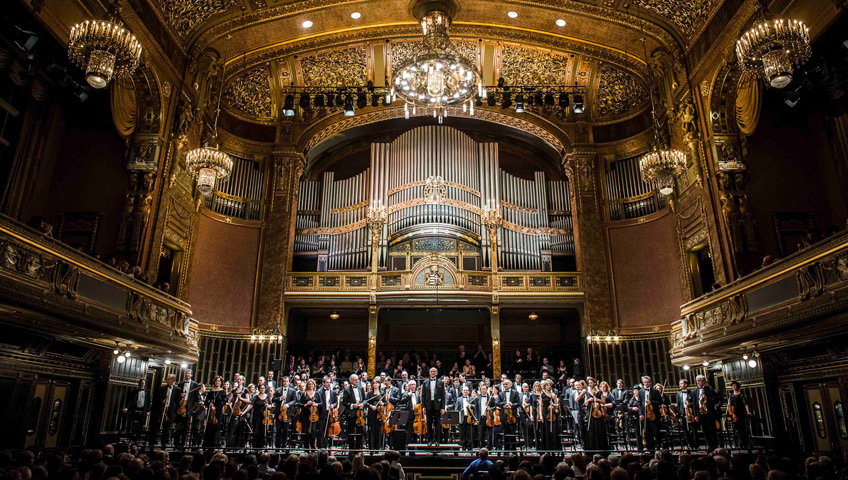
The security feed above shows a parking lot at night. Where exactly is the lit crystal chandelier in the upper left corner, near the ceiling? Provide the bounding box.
[68,0,142,88]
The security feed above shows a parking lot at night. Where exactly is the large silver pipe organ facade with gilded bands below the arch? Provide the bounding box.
[295,126,575,271]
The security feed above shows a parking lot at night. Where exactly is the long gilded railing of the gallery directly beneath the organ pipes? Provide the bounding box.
[286,270,583,292]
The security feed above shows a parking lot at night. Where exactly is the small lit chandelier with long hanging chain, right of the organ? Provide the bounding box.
[639,32,686,195]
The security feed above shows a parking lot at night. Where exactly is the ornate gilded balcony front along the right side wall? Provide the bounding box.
[671,231,848,362]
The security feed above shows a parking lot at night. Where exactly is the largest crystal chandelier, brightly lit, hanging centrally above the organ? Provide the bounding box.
[393,5,482,121]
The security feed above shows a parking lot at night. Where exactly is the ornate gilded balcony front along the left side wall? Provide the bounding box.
[0,216,198,360]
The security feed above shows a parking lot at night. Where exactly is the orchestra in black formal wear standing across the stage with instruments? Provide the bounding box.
[129,368,752,452]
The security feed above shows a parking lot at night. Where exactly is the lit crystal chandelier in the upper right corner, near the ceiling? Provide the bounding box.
[736,4,812,88]
